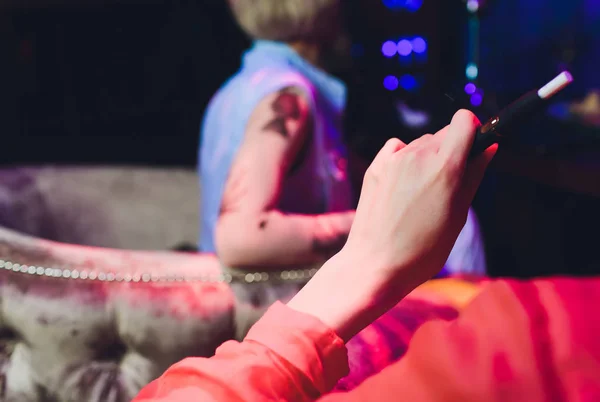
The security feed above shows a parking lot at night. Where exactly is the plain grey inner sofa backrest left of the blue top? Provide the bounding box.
[0,166,200,250]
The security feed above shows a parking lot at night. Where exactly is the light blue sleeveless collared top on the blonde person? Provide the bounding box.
[198,41,352,253]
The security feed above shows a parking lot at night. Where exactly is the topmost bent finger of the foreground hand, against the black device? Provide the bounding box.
[440,109,481,164]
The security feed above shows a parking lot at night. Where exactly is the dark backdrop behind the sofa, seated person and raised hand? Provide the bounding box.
[0,0,600,276]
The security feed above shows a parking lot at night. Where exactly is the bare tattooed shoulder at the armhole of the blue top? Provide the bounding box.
[248,87,310,139]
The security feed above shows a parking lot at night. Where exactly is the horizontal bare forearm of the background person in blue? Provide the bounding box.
[216,211,354,269]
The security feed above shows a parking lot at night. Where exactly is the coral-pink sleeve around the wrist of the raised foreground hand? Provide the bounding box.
[134,303,348,402]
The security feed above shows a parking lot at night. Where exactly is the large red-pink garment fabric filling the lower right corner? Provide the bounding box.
[319,278,600,402]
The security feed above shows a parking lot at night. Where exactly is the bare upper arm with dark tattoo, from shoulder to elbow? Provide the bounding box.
[221,88,311,213]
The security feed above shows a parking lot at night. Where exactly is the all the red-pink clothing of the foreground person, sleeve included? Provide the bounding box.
[136,279,600,402]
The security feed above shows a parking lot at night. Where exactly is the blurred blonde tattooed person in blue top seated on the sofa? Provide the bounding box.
[199,0,485,286]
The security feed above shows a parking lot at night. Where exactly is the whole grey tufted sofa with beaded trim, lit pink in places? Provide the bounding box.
[0,168,474,402]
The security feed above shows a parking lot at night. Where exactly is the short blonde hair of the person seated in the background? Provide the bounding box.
[229,0,341,42]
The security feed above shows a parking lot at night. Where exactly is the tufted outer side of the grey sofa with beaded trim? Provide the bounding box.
[0,230,310,401]
